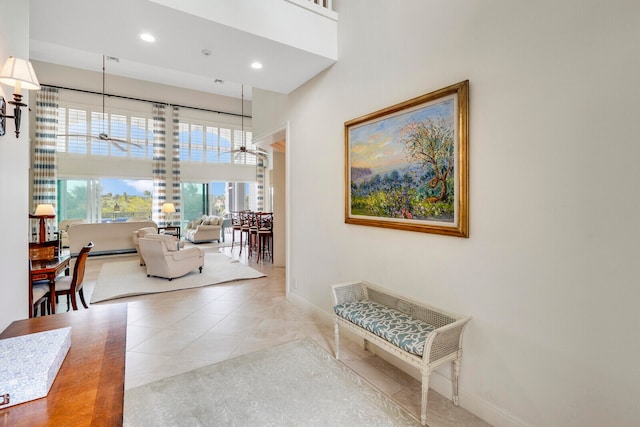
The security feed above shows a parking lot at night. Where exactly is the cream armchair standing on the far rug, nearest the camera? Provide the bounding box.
[138,237,204,280]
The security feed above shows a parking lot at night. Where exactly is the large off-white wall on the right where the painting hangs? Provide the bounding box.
[253,0,640,427]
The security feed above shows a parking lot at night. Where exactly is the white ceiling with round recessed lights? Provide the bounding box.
[30,0,334,99]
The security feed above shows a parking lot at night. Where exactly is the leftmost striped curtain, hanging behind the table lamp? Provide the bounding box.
[32,86,59,211]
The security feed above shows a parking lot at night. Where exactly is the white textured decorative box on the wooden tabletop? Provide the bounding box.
[0,328,71,409]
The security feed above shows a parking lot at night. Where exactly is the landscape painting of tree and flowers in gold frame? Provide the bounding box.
[344,80,469,237]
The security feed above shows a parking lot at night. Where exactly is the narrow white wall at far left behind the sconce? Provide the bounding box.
[0,0,30,331]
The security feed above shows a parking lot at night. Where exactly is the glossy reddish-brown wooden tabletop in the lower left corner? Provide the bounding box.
[0,304,127,427]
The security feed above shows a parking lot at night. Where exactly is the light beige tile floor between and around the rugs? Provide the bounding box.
[58,247,488,427]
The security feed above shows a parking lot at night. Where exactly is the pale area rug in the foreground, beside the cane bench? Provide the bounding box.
[124,338,420,427]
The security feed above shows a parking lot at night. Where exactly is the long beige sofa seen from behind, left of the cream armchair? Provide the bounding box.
[67,220,158,256]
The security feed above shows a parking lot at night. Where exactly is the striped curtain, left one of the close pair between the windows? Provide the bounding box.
[151,104,167,226]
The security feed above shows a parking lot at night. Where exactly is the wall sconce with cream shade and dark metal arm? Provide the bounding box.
[0,56,40,138]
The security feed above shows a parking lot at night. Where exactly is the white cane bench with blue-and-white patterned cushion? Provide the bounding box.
[331,282,471,425]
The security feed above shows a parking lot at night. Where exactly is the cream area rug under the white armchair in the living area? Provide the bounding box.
[91,252,264,304]
